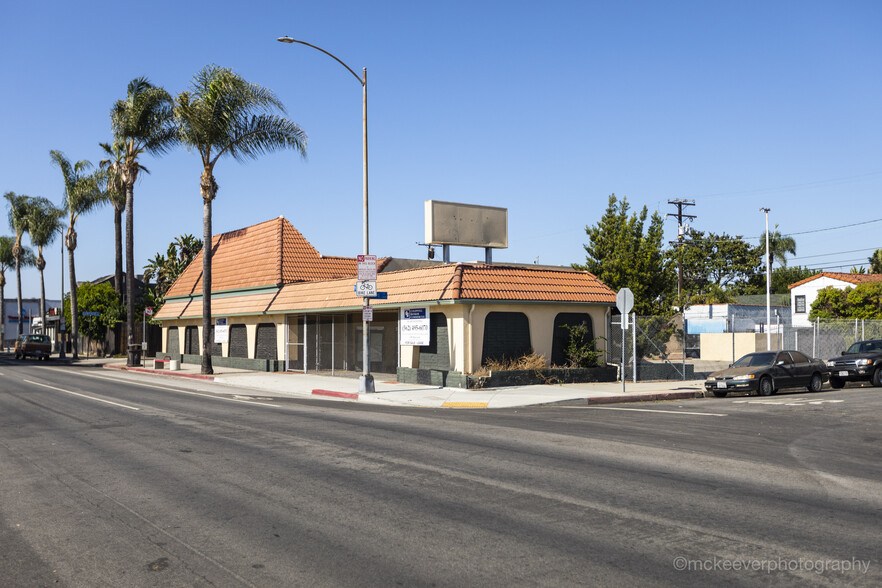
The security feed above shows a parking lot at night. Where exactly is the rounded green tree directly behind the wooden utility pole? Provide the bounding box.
[671,231,760,304]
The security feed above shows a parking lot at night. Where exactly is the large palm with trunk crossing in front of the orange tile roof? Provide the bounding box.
[175,65,306,374]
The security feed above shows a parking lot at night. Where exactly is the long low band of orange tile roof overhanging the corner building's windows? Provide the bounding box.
[156,263,616,320]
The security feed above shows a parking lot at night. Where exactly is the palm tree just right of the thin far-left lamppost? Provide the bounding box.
[49,150,107,359]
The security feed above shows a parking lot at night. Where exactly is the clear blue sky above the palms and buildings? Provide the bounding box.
[0,0,882,298]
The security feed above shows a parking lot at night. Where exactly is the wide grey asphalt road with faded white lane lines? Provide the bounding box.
[0,359,882,587]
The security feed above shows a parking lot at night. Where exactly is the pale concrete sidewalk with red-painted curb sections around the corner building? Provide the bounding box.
[93,359,704,408]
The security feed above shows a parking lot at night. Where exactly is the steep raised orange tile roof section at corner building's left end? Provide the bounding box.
[166,217,356,298]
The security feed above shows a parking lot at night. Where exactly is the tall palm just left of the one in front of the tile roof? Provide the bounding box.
[110,77,178,366]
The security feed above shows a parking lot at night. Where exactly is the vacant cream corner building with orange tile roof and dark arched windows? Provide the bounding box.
[156,217,615,385]
